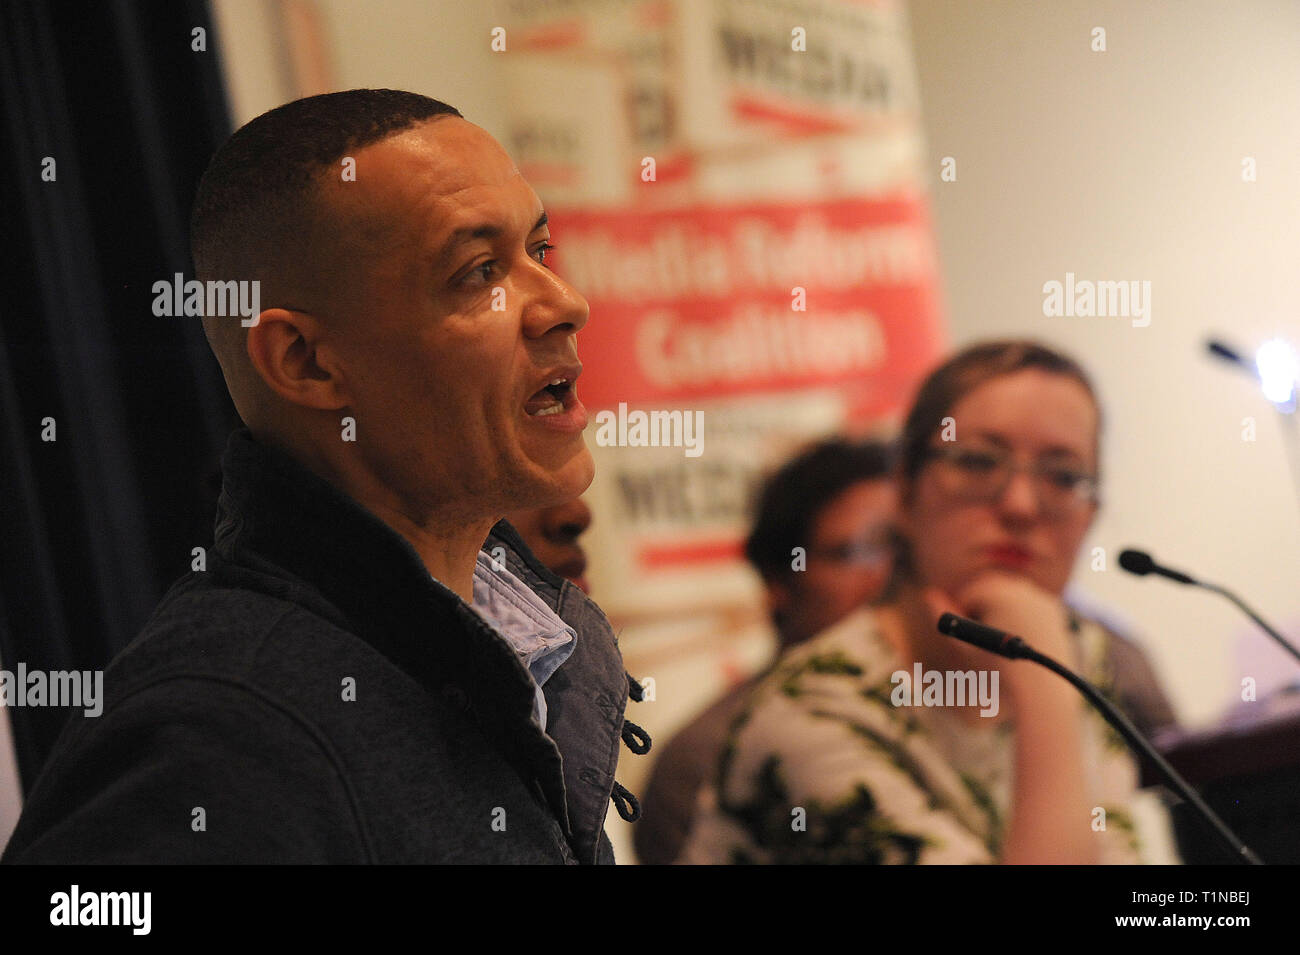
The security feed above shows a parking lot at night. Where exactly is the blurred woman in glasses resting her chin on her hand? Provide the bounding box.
[681,342,1171,864]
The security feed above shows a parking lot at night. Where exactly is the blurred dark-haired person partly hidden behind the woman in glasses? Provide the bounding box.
[633,438,896,864]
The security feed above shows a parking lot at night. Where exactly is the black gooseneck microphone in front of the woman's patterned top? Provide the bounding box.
[939,613,1264,865]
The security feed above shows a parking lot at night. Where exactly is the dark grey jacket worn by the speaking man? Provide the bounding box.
[4,429,645,863]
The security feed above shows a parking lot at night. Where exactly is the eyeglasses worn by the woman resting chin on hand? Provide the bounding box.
[926,446,1100,517]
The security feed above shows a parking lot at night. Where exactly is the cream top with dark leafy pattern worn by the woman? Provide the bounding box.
[677,609,1141,864]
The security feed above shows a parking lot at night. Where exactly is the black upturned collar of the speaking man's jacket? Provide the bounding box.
[213,427,569,834]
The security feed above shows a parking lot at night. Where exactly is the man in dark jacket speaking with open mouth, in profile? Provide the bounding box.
[4,90,642,863]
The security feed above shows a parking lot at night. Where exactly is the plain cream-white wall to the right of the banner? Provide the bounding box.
[910,0,1300,724]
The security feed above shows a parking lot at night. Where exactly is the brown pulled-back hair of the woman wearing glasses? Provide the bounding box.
[898,339,1101,487]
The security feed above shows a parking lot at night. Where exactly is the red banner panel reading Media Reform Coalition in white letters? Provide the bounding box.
[551,199,943,420]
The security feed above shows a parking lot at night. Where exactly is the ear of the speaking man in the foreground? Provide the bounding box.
[244,308,348,411]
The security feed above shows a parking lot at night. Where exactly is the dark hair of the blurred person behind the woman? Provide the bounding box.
[745,438,892,579]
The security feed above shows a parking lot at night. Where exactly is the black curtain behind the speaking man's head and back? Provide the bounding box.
[0,0,238,790]
